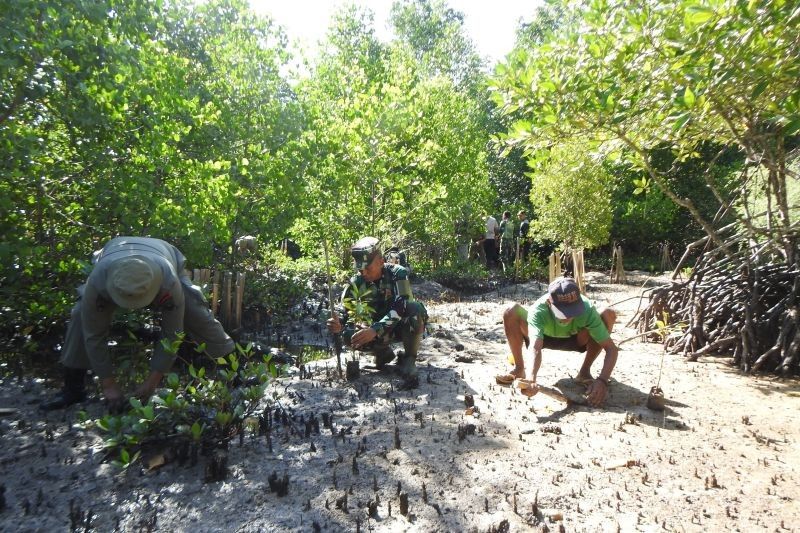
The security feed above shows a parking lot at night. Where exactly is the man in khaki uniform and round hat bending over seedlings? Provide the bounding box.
[41,237,235,412]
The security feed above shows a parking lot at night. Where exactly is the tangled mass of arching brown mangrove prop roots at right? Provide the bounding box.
[631,235,800,376]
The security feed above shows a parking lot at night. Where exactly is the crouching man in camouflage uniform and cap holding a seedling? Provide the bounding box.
[328,237,428,383]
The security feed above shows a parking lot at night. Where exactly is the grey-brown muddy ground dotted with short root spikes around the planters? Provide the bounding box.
[0,274,800,532]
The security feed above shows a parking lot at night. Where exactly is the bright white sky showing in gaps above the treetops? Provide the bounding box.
[250,0,542,64]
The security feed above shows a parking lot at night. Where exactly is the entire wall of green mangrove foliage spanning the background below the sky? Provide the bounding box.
[0,0,800,354]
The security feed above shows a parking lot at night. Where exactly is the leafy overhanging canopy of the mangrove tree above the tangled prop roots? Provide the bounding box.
[494,0,800,263]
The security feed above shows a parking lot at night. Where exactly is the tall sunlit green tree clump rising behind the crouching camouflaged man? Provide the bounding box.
[296,0,490,262]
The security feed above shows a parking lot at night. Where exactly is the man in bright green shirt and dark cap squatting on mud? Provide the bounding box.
[498,277,619,407]
